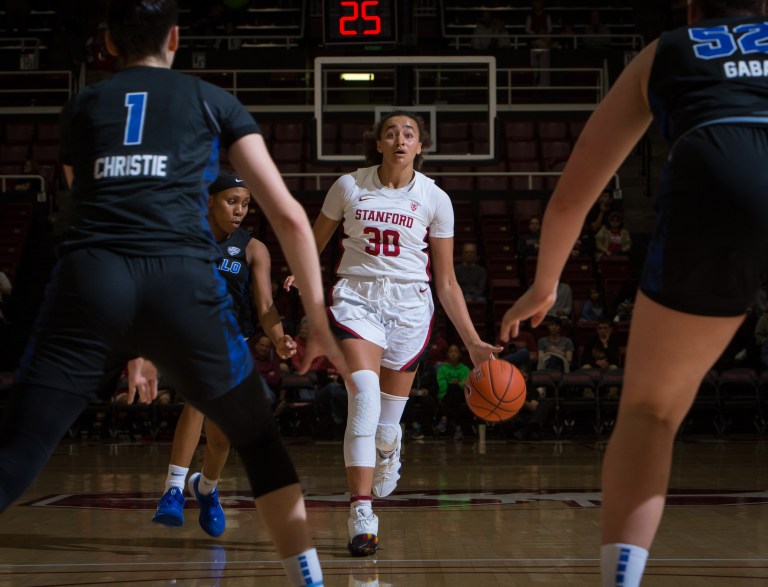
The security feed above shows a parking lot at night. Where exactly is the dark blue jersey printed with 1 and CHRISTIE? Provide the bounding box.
[61,66,259,261]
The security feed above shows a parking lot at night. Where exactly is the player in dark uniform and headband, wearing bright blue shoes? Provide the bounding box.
[152,174,297,537]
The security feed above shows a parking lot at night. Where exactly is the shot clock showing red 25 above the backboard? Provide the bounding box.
[323,0,397,45]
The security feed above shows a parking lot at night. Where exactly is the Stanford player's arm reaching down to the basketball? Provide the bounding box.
[429,237,502,365]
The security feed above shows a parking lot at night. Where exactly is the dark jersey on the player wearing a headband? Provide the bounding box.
[217,228,254,338]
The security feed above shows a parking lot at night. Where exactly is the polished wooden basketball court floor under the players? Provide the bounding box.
[0,439,768,587]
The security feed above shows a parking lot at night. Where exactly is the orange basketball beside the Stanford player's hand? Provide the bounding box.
[464,359,525,423]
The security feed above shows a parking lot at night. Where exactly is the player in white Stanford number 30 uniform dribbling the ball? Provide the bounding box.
[286,111,501,556]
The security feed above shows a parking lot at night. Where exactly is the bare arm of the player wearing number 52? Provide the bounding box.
[501,42,656,341]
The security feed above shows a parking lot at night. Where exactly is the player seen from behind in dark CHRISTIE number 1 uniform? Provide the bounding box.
[0,0,347,585]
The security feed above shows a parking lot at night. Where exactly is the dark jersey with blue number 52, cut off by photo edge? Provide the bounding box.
[648,17,768,143]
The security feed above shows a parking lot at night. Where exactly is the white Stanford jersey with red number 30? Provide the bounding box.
[323,165,453,281]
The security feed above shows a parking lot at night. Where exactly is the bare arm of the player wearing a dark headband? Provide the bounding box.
[245,238,296,359]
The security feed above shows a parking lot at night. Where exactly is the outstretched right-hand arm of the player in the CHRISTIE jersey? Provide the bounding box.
[229,134,349,379]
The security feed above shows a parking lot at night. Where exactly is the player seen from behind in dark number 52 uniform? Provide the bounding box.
[501,0,768,587]
